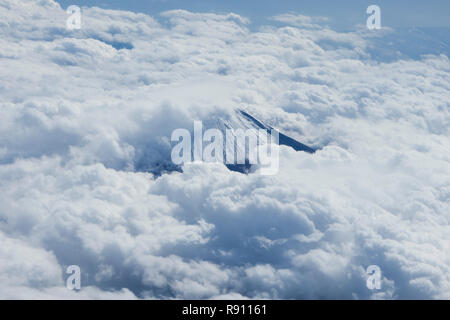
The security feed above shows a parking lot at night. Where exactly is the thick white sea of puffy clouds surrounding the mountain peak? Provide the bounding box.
[0,0,450,299]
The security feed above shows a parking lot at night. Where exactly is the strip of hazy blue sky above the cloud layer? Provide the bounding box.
[58,0,450,30]
